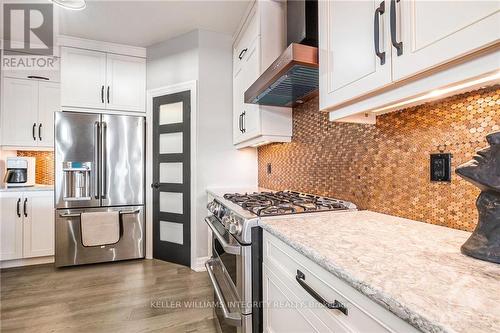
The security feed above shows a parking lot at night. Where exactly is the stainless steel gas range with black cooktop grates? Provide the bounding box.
[205,191,356,333]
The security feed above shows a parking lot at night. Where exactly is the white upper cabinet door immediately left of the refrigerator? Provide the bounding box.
[37,82,61,147]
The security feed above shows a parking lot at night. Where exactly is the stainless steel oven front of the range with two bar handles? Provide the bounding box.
[205,216,252,332]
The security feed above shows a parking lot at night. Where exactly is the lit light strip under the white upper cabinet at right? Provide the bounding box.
[371,71,500,114]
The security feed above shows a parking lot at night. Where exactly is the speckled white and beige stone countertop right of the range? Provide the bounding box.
[260,211,500,333]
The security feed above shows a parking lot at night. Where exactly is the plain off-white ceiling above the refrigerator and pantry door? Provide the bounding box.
[58,0,250,47]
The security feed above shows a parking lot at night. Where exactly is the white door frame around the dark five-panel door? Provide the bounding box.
[146,80,198,269]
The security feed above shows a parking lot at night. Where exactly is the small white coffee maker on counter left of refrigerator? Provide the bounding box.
[4,157,36,187]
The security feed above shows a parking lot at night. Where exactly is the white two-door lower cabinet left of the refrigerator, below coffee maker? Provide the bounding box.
[0,191,54,261]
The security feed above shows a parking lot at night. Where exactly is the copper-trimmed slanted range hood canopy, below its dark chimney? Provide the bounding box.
[245,43,319,107]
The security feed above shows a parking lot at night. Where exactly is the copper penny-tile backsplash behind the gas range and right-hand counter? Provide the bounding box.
[258,86,500,231]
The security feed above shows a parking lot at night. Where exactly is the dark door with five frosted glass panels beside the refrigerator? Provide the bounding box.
[152,91,191,266]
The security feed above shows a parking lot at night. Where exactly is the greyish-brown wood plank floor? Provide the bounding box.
[0,260,216,333]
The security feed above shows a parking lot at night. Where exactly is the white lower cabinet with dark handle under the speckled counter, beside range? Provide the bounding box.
[262,232,419,333]
